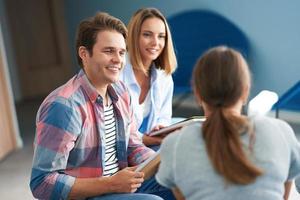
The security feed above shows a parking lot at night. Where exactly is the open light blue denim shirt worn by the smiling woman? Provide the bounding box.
[120,63,174,134]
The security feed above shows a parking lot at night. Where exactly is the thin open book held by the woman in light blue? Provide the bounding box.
[149,116,205,136]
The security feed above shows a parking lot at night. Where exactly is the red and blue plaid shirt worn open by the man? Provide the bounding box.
[30,70,153,200]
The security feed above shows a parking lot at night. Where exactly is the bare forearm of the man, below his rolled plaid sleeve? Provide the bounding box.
[68,177,116,199]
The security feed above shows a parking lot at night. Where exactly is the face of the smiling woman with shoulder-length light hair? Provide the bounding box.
[139,17,166,67]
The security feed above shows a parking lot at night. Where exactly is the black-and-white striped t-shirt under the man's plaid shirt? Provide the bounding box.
[103,103,119,176]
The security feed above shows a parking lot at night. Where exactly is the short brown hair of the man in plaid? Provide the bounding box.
[76,12,127,67]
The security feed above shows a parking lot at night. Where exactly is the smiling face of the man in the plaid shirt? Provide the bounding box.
[79,30,126,88]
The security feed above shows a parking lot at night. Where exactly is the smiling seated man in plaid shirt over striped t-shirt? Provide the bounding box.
[30,13,171,200]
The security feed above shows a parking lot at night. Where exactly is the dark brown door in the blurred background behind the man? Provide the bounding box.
[3,0,73,100]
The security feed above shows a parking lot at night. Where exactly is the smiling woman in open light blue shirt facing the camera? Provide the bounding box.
[120,8,177,149]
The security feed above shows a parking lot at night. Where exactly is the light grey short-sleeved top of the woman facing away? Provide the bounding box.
[156,117,300,200]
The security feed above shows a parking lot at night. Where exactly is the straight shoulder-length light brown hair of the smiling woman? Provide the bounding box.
[127,8,177,74]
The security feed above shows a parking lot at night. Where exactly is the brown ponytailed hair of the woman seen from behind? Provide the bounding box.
[193,46,263,184]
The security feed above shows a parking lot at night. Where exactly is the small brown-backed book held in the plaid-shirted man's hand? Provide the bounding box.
[135,150,160,180]
